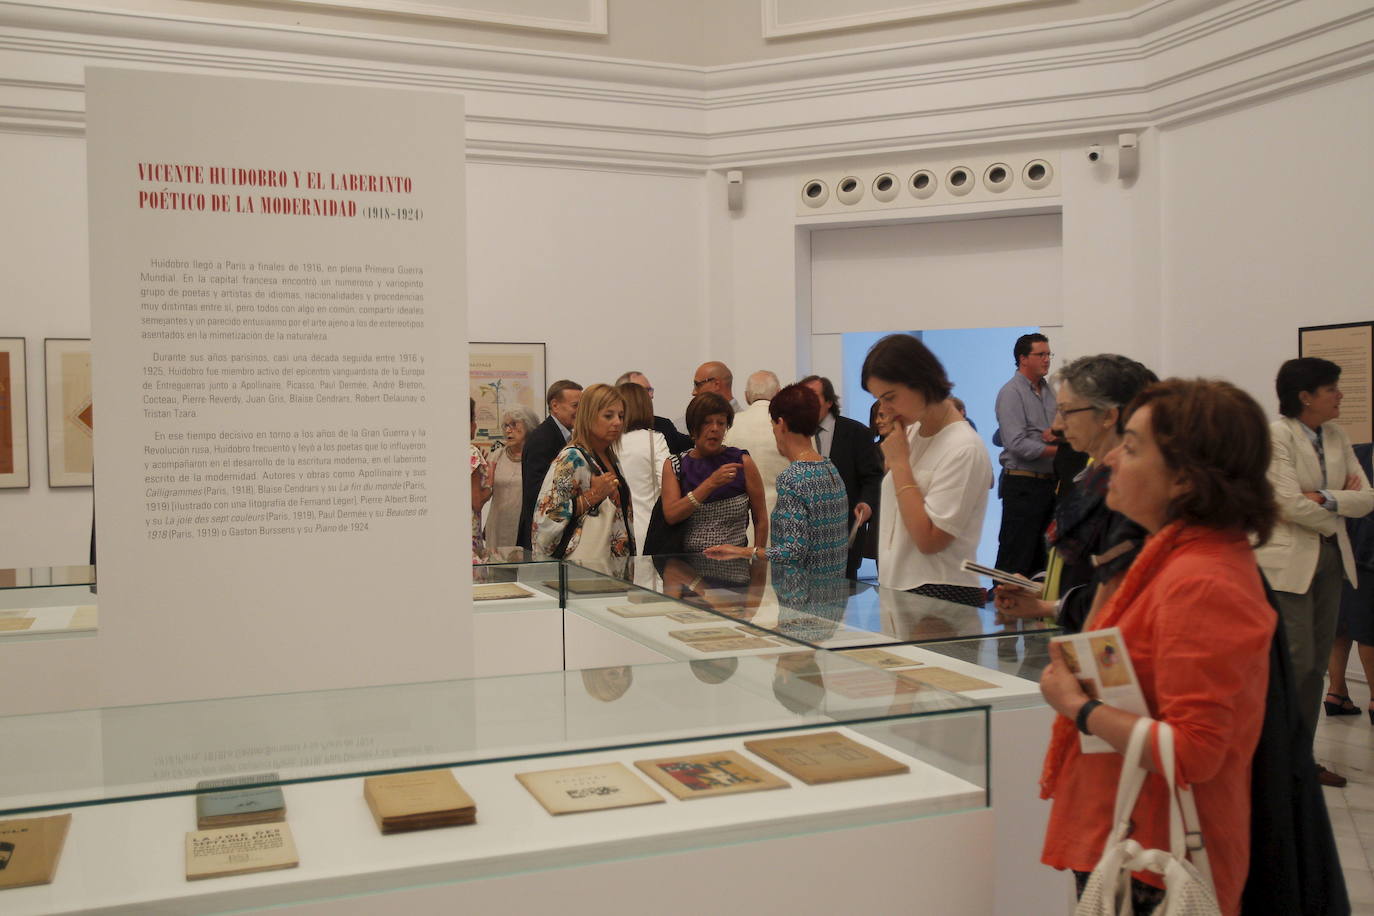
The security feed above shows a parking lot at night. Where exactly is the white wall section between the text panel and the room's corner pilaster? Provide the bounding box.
[467,163,703,417]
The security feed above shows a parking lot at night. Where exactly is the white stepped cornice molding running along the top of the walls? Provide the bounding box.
[0,0,1374,174]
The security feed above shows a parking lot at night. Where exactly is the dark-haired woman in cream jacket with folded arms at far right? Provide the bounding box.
[1256,357,1374,786]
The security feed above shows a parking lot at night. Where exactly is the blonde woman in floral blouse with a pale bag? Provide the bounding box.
[530,385,635,560]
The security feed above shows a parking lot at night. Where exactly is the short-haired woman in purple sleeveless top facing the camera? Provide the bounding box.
[664,393,768,553]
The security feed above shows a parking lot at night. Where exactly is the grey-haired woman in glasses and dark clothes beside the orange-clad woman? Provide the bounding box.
[996,353,1158,633]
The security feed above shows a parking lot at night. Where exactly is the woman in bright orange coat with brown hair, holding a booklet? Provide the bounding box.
[1040,379,1278,915]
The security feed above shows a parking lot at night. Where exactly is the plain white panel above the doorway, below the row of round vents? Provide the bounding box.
[811,214,1063,334]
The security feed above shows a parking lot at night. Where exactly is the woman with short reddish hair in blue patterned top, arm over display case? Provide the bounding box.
[706,385,849,580]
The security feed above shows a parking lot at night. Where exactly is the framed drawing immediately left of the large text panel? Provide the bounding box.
[43,338,95,486]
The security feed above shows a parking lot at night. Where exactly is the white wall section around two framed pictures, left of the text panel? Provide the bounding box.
[0,135,91,567]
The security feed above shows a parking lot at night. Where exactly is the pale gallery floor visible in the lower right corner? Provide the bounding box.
[1316,703,1374,916]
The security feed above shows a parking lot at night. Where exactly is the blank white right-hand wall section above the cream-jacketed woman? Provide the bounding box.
[1161,73,1374,416]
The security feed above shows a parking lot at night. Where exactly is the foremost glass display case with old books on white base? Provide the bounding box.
[0,650,989,913]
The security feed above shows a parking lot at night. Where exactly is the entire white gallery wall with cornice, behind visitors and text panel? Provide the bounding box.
[0,0,1374,566]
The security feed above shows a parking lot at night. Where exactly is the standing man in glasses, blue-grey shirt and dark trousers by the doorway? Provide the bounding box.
[996,334,1058,575]
